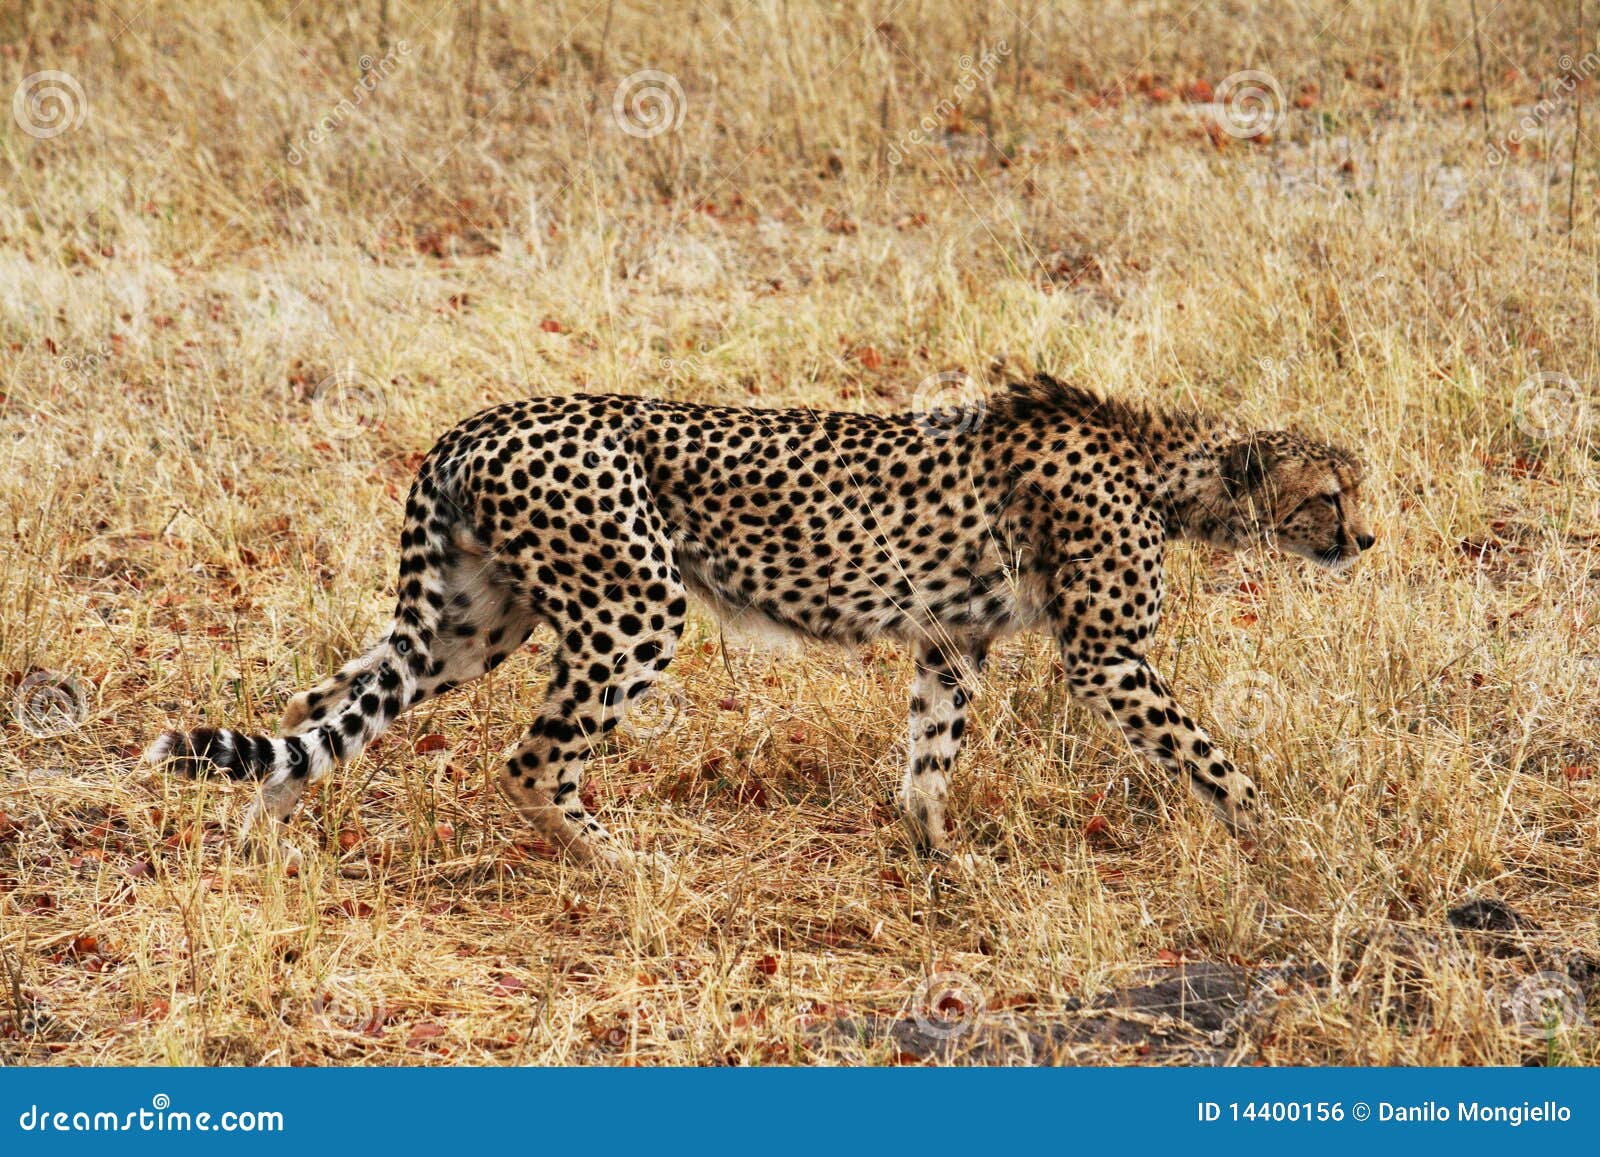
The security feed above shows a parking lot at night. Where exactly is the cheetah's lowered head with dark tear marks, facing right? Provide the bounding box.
[1218,430,1374,570]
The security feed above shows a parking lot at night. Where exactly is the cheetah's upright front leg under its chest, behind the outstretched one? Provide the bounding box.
[901,643,979,855]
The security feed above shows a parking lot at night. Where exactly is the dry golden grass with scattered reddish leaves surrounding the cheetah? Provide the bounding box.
[0,0,1600,1064]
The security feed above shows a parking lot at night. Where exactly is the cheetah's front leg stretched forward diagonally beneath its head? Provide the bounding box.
[1062,648,1256,835]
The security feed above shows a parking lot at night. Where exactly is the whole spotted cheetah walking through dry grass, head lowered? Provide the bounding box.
[147,374,1373,864]
